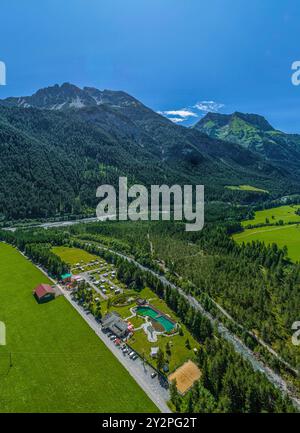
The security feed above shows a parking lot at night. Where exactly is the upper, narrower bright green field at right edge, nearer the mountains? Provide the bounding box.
[242,205,300,227]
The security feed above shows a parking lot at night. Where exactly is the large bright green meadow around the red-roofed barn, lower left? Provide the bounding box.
[0,244,157,412]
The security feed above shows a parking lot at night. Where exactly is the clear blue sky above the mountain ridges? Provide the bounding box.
[0,0,300,133]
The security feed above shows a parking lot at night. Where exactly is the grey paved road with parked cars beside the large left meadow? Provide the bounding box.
[60,287,171,413]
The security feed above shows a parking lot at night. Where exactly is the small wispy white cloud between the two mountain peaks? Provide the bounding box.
[158,101,224,123]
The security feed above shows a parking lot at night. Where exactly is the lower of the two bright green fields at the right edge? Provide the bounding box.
[233,224,300,261]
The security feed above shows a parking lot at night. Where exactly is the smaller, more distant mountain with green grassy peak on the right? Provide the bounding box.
[194,112,300,177]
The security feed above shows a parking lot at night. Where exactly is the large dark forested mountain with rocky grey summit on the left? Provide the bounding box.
[0,83,297,219]
